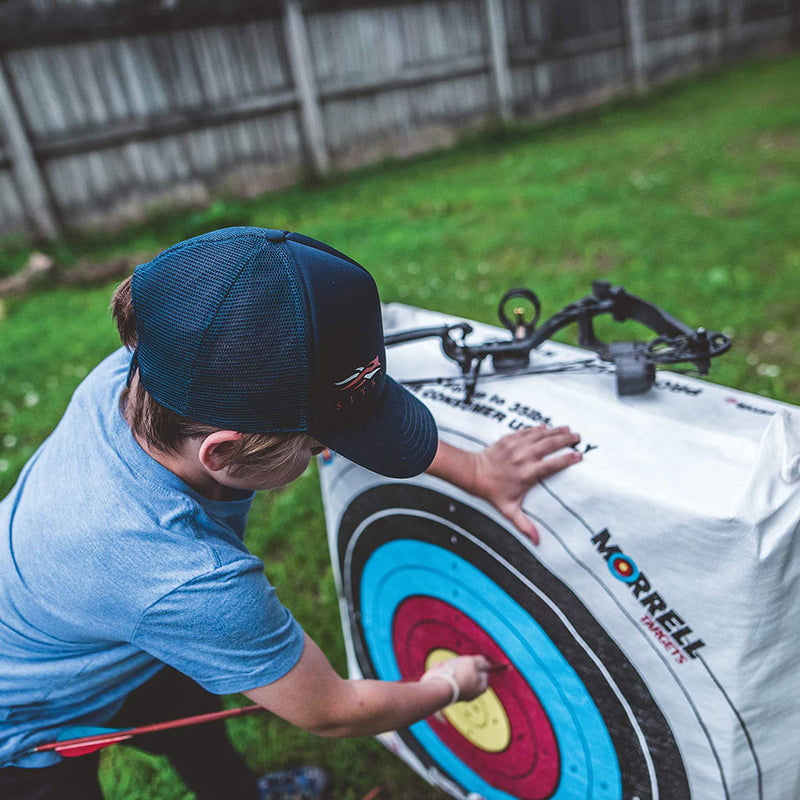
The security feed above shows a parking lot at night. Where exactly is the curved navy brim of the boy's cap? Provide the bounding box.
[309,376,439,478]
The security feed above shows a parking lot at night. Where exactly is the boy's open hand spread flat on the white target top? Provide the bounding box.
[473,425,582,544]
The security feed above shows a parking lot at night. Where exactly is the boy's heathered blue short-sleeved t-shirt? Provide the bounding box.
[0,349,303,767]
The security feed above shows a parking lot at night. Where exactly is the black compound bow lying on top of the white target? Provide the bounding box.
[385,281,731,401]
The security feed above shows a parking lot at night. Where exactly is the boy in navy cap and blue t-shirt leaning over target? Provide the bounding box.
[0,228,579,800]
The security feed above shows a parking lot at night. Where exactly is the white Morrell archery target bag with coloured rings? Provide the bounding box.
[320,305,800,800]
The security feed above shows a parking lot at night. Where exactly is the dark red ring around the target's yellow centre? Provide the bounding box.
[392,596,560,800]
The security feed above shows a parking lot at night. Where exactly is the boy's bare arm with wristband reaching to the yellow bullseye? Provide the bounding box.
[244,635,489,737]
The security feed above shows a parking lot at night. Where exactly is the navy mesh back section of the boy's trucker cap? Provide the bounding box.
[134,229,310,432]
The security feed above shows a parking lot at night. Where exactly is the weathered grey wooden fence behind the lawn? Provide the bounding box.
[0,0,800,236]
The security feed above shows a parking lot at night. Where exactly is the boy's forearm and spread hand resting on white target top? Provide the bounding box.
[427,425,581,544]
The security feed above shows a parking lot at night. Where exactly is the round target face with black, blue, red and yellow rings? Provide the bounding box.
[337,484,690,800]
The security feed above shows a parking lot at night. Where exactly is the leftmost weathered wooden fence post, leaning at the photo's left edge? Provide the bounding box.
[0,60,58,239]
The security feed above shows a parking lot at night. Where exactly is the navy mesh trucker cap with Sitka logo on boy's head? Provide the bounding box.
[131,228,437,478]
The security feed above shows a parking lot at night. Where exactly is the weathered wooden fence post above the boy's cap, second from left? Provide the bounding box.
[283,0,330,175]
